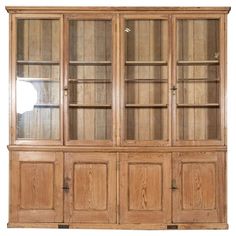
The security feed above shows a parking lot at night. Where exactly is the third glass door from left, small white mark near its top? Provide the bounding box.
[121,15,170,145]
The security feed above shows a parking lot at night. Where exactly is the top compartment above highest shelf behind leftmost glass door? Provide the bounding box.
[17,19,60,62]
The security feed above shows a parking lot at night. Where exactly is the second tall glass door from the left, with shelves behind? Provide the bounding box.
[65,15,114,145]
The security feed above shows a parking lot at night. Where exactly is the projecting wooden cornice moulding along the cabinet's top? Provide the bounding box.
[5,6,231,13]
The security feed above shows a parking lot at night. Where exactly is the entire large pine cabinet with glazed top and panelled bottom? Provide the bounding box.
[7,7,230,229]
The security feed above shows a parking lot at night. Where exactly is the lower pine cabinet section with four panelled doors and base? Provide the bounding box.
[9,151,227,229]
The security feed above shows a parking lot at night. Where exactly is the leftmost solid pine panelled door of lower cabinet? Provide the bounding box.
[10,152,63,223]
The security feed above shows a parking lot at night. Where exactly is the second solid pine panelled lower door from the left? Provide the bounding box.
[64,153,116,223]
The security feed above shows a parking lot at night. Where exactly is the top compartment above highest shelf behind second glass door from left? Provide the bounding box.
[69,20,112,61]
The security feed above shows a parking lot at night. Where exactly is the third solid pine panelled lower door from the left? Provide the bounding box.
[120,153,171,224]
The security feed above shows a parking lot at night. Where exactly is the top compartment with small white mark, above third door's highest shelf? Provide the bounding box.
[124,20,168,61]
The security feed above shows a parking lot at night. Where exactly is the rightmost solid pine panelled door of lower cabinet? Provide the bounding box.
[173,152,226,223]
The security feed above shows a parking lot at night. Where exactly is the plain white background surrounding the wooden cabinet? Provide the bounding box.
[0,0,236,236]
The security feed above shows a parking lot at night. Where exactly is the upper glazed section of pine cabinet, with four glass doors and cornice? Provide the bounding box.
[7,7,229,147]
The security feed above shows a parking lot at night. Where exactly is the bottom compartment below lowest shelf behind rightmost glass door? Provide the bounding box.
[177,108,220,141]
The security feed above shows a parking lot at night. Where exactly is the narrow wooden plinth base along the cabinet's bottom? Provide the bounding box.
[7,223,228,230]
